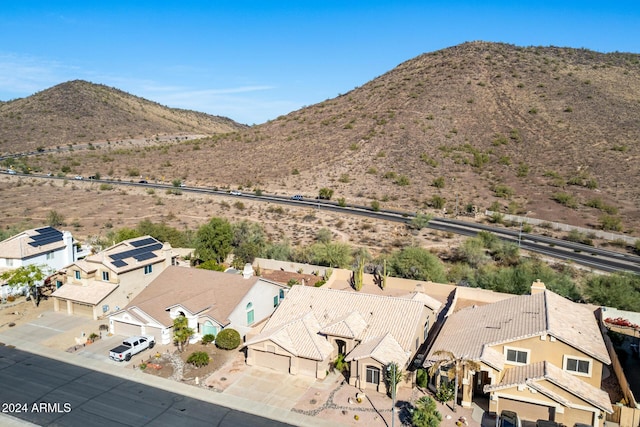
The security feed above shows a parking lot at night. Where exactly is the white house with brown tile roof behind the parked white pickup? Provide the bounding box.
[109,265,289,344]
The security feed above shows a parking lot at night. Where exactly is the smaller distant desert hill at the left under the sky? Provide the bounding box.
[0,80,246,152]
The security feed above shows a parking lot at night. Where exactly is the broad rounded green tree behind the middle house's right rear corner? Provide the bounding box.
[388,246,446,283]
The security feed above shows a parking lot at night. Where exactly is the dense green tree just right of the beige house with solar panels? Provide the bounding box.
[195,217,233,264]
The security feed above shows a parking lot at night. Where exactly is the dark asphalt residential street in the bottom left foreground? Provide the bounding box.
[0,346,287,427]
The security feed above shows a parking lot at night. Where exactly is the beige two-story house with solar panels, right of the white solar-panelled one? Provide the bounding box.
[51,236,173,319]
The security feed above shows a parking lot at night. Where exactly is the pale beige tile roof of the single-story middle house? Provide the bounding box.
[245,286,425,365]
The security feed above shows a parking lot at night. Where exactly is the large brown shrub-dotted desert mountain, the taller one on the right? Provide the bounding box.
[8,42,640,232]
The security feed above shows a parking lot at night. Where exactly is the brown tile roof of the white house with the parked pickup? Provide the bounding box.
[120,266,259,327]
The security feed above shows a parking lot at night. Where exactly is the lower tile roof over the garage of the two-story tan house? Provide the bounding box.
[484,361,613,413]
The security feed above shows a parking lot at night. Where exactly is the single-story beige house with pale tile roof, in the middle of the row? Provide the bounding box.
[245,286,436,392]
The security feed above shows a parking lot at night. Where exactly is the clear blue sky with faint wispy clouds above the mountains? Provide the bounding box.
[0,0,640,124]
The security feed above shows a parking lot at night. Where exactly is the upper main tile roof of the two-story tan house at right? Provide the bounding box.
[425,290,611,369]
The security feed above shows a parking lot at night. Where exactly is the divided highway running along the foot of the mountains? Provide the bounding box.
[0,171,640,274]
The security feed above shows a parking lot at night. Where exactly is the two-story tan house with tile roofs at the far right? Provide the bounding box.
[425,281,612,427]
